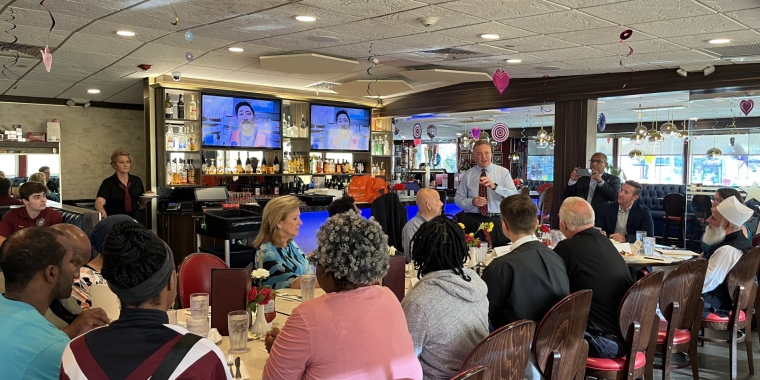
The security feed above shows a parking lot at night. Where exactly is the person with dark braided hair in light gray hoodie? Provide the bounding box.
[401,215,488,379]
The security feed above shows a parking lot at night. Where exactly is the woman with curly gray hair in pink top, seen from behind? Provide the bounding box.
[263,212,422,380]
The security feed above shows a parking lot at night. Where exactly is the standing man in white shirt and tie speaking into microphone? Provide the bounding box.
[455,140,517,247]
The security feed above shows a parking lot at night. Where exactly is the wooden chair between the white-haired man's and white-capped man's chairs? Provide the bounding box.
[646,259,707,380]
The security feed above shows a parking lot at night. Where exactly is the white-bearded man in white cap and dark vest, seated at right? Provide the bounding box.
[702,197,752,318]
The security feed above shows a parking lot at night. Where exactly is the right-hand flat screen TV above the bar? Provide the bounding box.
[311,104,370,152]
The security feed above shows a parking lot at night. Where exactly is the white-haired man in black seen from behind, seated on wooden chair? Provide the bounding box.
[554,197,633,358]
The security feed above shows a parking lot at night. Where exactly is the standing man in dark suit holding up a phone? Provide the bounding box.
[564,152,621,214]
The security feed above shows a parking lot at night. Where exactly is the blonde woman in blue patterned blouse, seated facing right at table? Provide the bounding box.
[253,195,310,289]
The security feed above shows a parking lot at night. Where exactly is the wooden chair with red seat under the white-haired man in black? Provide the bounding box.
[586,271,663,380]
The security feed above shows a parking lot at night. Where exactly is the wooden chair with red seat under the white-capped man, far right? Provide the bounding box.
[699,248,760,379]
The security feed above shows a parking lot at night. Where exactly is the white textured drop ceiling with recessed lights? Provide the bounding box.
[0,0,760,110]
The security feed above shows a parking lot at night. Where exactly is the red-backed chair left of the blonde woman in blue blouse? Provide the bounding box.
[177,253,227,308]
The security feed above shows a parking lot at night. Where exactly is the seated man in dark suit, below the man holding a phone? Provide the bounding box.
[596,181,654,243]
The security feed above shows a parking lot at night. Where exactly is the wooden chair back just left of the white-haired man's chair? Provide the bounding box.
[533,289,592,380]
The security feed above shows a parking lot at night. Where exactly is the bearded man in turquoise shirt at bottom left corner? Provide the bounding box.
[0,227,79,379]
